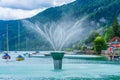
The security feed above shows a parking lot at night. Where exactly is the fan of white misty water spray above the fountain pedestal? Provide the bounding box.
[22,16,92,51]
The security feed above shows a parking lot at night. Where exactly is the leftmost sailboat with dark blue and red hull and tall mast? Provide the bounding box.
[2,25,11,60]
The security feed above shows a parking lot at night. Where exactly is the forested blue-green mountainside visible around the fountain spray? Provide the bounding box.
[0,0,120,50]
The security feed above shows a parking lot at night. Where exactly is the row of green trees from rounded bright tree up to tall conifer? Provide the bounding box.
[94,17,120,54]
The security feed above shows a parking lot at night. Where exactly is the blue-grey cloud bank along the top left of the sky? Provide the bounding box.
[0,0,51,10]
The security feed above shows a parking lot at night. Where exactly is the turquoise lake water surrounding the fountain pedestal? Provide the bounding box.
[0,54,120,80]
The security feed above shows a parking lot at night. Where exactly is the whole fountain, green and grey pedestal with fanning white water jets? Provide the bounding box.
[23,17,86,70]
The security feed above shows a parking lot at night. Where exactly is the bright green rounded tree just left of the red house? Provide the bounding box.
[94,36,107,54]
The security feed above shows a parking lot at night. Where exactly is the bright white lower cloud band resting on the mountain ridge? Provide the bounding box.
[0,7,44,20]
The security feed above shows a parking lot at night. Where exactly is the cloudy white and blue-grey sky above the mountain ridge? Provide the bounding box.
[0,0,75,20]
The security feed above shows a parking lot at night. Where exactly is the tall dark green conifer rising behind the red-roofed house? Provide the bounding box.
[112,17,120,37]
